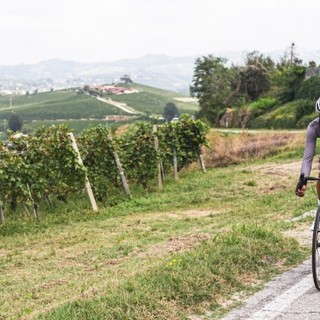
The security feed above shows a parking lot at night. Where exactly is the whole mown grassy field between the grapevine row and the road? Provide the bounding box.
[0,151,315,320]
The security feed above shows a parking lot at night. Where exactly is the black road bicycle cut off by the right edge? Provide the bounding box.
[296,174,320,291]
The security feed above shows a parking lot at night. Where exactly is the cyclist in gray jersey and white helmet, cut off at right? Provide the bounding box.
[296,97,320,206]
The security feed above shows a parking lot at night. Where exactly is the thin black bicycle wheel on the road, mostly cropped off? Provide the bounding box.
[312,206,320,291]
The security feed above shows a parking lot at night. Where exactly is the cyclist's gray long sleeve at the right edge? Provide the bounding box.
[301,117,320,177]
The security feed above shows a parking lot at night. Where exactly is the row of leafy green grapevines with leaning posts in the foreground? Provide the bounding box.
[0,115,208,223]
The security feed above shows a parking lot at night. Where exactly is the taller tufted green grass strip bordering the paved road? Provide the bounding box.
[39,225,305,320]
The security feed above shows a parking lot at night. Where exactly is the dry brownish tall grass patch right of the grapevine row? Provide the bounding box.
[203,131,305,167]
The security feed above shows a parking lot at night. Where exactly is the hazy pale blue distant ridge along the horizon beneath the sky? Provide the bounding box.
[0,50,320,93]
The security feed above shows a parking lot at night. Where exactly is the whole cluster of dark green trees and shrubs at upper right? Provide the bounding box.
[190,43,320,127]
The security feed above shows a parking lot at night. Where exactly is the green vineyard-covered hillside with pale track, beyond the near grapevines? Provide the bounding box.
[0,83,198,131]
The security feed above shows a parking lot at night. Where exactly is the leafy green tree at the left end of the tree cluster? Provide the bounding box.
[190,55,239,125]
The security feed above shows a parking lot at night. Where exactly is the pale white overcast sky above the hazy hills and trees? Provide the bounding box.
[0,0,320,65]
